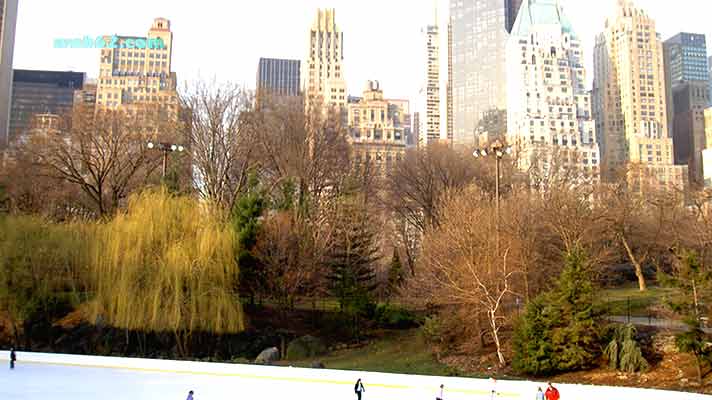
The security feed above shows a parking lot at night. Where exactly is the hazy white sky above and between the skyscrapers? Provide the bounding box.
[14,0,712,104]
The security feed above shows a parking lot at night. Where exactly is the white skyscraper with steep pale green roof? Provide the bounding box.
[507,0,600,181]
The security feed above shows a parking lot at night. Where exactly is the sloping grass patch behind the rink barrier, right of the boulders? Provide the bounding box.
[284,330,462,376]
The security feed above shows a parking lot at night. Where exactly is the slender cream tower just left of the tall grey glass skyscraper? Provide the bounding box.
[419,18,441,146]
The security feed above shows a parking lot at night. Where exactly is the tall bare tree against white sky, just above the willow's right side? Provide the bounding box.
[180,82,255,209]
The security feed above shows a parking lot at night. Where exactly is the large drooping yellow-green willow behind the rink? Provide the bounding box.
[92,190,244,336]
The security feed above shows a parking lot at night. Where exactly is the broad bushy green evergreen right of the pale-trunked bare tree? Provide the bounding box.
[513,248,600,375]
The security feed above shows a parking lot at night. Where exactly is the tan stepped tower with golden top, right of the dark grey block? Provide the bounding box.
[302,9,348,108]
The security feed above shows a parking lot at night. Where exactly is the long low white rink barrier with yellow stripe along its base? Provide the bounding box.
[0,351,712,400]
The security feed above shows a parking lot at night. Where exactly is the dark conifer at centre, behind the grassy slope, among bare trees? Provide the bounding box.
[326,204,379,313]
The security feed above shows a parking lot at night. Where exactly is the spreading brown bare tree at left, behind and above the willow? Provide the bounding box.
[27,110,171,216]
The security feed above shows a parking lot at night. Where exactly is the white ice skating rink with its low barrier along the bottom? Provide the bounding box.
[0,352,712,400]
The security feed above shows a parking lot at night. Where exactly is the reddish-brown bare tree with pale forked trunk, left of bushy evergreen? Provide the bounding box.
[414,188,520,366]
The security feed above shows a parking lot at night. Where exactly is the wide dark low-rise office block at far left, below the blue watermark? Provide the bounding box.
[10,69,85,141]
